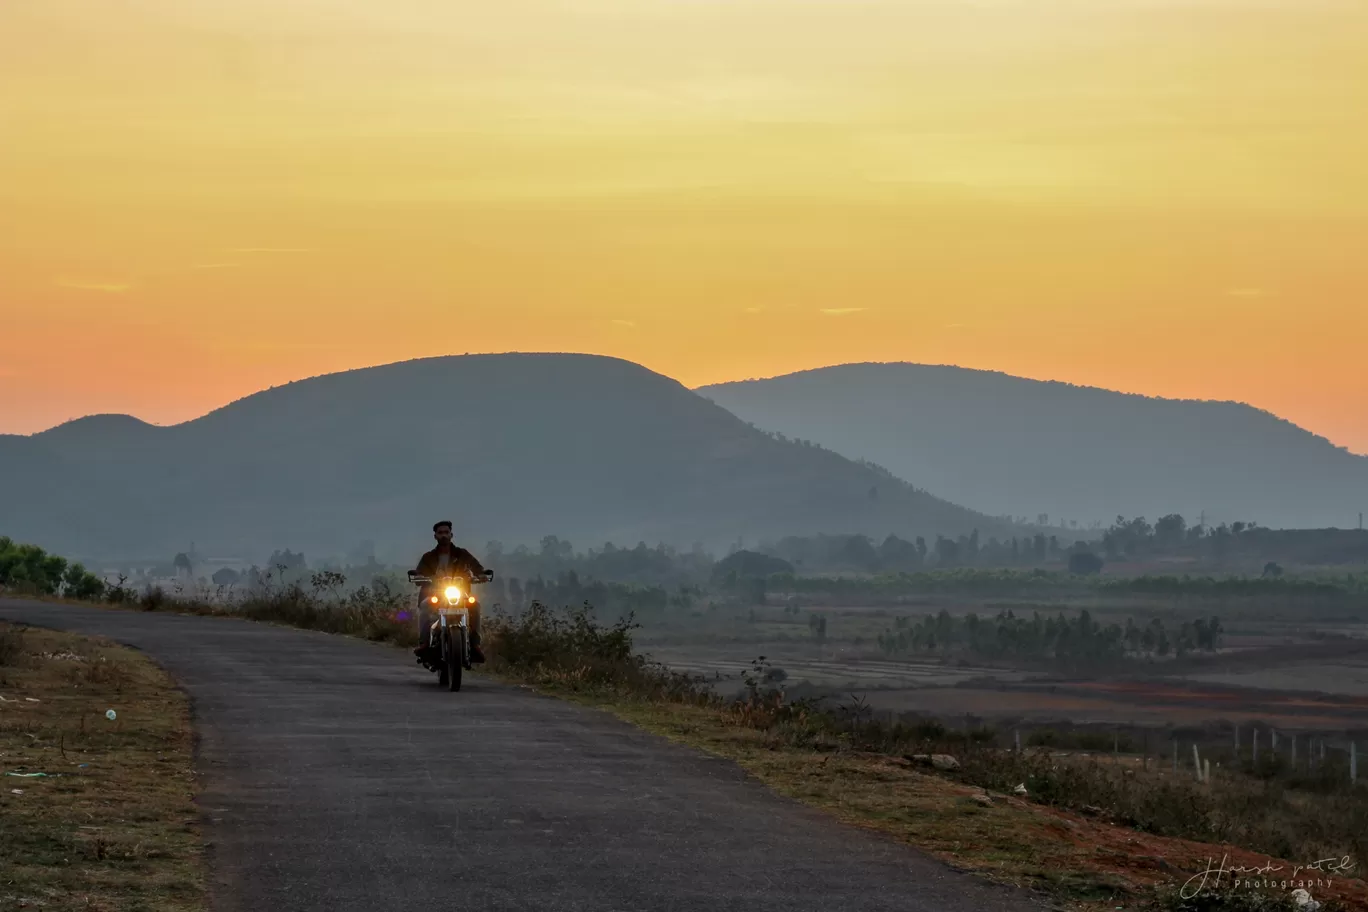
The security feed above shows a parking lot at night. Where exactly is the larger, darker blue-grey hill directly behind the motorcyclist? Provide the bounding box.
[0,354,1028,559]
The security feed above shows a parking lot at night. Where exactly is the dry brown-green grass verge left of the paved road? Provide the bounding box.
[0,622,207,912]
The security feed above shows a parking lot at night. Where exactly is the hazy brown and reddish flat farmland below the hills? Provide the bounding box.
[626,584,1368,779]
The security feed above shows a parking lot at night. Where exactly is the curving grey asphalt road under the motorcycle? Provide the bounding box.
[0,602,1041,912]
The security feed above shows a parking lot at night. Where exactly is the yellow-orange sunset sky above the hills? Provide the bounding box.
[0,0,1368,454]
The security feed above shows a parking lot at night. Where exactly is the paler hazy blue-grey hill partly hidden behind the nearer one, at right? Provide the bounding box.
[699,364,1368,528]
